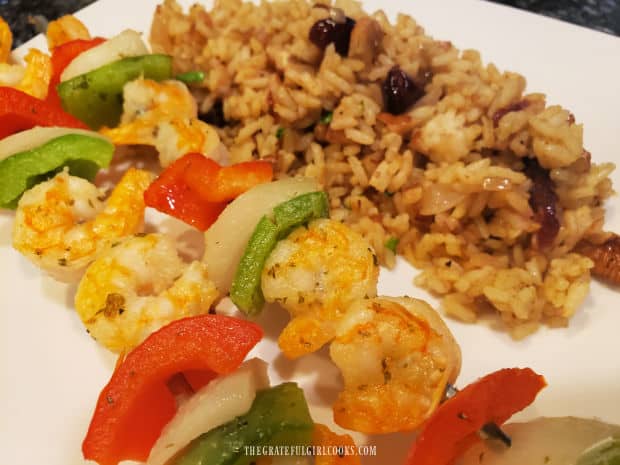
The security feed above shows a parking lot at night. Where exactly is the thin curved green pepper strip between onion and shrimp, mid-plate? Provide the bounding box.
[230,192,329,315]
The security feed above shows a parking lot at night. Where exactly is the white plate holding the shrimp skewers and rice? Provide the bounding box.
[0,0,620,465]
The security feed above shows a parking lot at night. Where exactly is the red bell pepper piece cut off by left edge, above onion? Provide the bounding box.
[0,87,88,139]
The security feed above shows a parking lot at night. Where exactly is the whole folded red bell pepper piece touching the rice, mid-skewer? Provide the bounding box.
[144,153,273,231]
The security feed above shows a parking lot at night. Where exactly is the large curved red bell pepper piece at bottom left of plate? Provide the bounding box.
[82,315,262,465]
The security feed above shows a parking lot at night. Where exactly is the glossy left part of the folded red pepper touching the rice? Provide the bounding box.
[144,153,226,231]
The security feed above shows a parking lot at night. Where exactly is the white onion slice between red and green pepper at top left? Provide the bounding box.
[60,29,149,82]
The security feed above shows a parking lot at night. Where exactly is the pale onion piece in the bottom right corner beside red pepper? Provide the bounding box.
[456,417,620,465]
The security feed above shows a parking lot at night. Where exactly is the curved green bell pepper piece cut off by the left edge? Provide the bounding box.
[0,134,114,209]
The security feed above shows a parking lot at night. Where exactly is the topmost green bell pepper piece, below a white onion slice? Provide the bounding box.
[57,55,172,129]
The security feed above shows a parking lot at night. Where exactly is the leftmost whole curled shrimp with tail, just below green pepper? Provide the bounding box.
[13,169,152,281]
